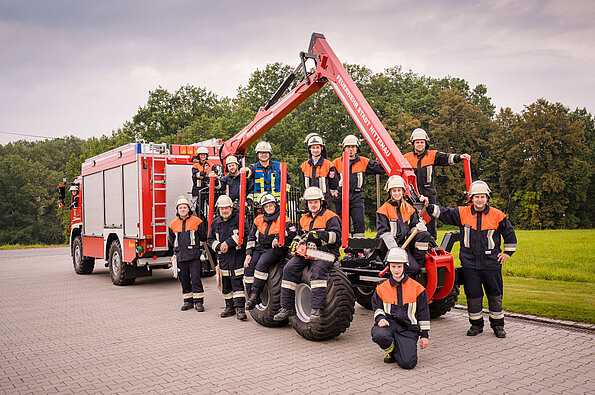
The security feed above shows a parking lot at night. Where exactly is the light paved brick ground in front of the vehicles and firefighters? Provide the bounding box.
[0,248,595,394]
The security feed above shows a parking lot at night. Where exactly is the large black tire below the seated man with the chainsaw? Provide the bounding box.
[289,265,355,341]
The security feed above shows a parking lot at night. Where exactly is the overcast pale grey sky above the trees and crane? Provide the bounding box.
[0,0,595,144]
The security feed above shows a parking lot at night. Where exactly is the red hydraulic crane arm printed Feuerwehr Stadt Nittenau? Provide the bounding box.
[221,33,416,186]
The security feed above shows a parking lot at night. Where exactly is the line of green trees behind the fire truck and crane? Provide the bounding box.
[0,63,595,244]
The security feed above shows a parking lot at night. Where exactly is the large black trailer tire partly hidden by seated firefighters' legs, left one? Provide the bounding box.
[250,261,288,327]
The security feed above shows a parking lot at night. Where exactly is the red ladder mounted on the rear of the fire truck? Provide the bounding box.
[149,143,169,251]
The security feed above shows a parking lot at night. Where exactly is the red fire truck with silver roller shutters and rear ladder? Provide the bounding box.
[60,139,222,285]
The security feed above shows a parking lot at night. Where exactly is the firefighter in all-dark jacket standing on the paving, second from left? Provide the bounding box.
[207,195,248,321]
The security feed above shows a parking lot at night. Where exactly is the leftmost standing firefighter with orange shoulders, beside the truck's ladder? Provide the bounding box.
[169,196,207,312]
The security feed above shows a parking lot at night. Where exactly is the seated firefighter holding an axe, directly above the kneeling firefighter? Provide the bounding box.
[376,175,432,275]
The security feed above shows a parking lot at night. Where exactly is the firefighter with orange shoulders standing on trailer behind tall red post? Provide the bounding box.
[332,134,386,248]
